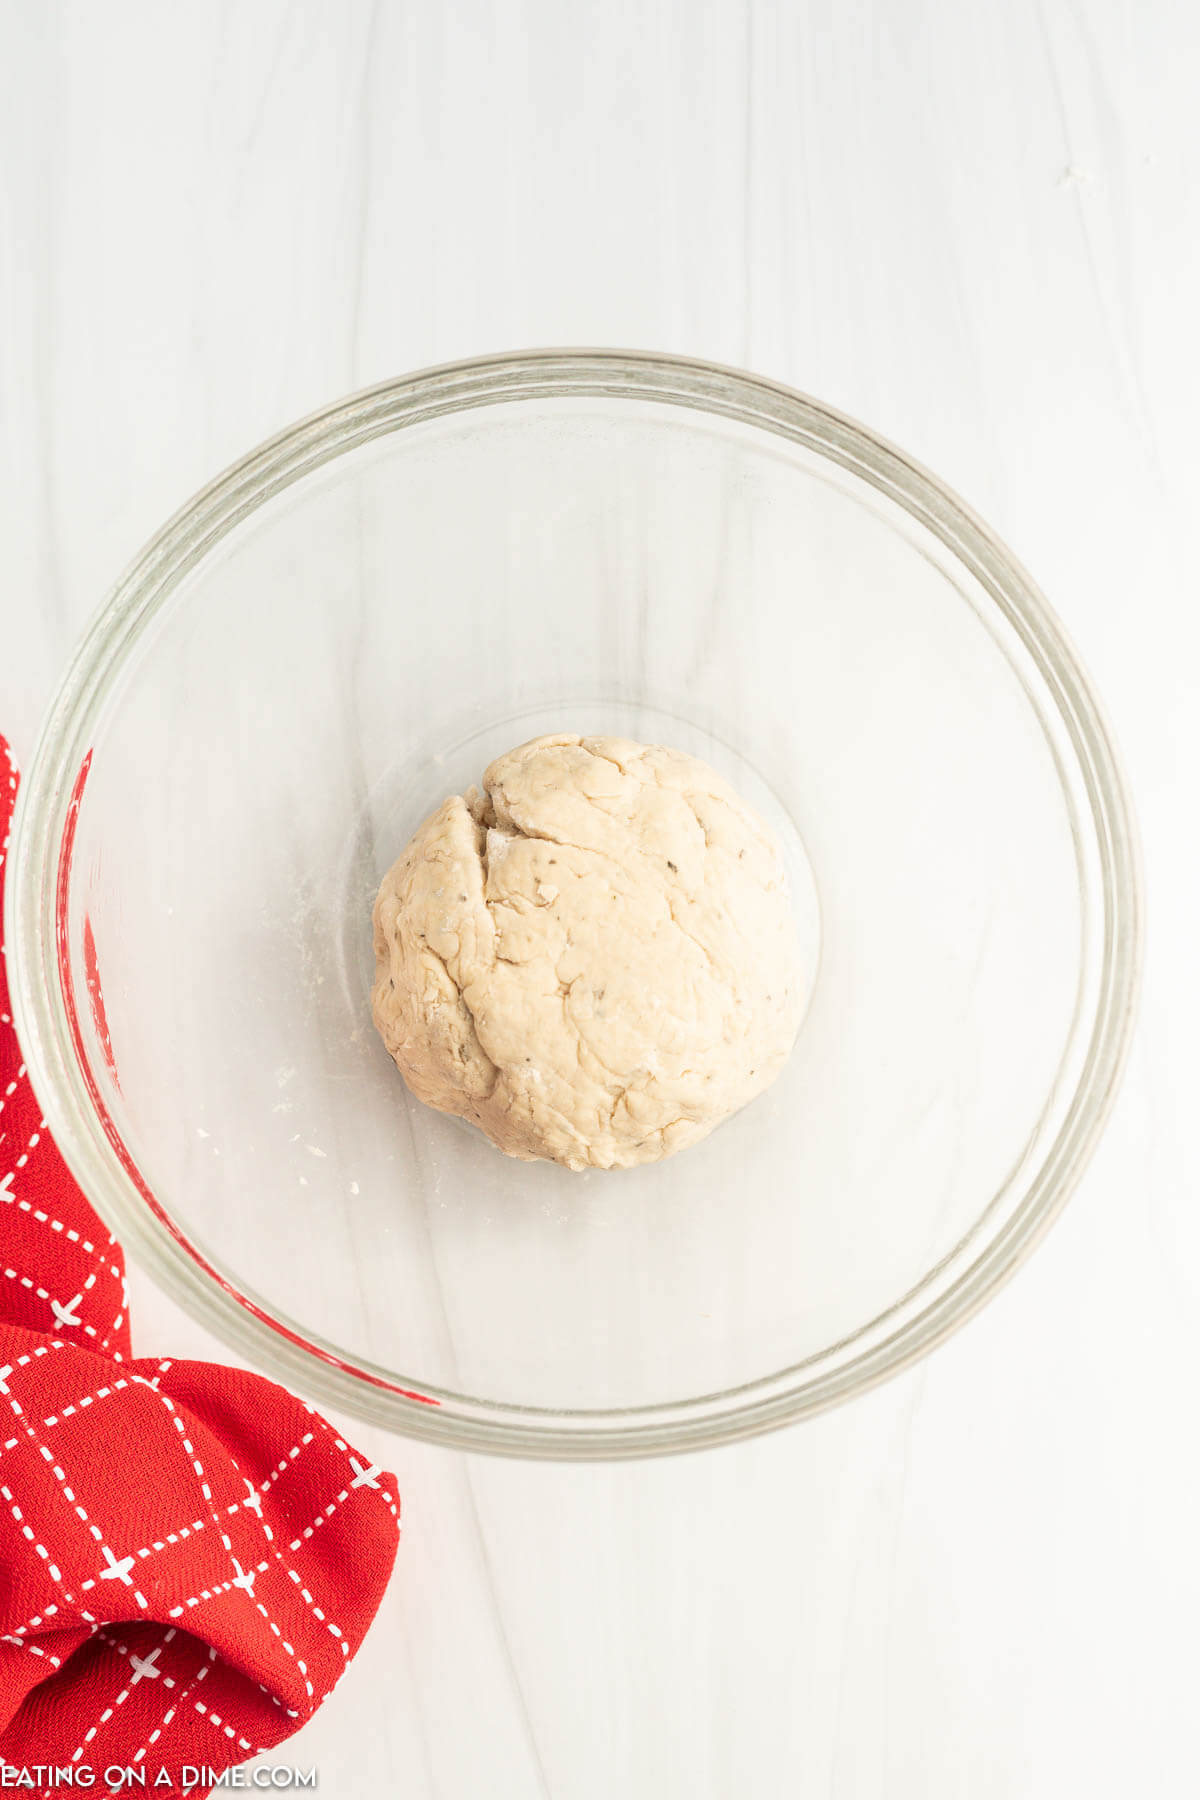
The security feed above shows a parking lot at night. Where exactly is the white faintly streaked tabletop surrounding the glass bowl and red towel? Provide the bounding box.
[0,0,1200,1800]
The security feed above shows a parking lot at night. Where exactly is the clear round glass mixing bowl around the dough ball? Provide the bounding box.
[9,351,1139,1456]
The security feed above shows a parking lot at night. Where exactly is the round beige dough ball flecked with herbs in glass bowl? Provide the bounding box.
[372,736,811,1168]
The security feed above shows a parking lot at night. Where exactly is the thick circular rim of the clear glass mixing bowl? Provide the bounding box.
[5,347,1142,1460]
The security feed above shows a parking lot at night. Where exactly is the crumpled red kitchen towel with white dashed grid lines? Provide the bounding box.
[0,738,399,1795]
